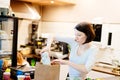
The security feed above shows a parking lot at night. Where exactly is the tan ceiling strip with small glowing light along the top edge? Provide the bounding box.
[15,0,75,5]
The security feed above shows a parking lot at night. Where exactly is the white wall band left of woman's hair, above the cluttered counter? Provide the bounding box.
[41,22,76,35]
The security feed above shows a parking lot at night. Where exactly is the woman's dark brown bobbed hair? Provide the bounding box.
[75,22,95,44]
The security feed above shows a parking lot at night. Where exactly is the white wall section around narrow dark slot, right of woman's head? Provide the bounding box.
[101,24,120,50]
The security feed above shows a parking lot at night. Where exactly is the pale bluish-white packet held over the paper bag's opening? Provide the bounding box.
[41,52,51,65]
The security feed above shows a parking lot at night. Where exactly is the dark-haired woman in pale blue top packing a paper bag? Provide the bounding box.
[41,22,98,80]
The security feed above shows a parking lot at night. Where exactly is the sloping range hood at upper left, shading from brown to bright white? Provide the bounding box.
[10,0,41,20]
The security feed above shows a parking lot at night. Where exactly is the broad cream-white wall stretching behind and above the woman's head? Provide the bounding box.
[41,0,120,49]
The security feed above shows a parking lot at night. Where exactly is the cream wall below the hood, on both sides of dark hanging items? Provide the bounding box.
[17,20,41,49]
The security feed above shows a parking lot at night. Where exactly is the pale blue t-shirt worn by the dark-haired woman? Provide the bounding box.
[55,36,98,77]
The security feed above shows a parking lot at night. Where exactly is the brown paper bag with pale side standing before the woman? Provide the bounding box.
[34,62,68,80]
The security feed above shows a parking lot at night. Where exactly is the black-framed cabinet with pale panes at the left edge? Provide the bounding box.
[0,16,18,67]
